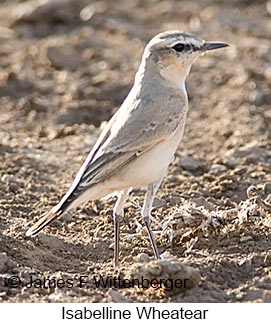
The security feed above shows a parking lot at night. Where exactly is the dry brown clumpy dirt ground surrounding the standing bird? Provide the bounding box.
[0,0,271,302]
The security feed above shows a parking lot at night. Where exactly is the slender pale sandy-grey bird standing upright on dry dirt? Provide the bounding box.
[25,30,229,267]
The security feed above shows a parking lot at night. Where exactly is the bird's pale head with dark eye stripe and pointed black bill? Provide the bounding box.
[142,31,229,87]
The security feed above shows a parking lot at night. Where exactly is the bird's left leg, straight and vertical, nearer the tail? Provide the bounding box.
[113,189,129,267]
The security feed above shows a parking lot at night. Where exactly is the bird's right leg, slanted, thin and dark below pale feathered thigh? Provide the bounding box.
[141,179,162,259]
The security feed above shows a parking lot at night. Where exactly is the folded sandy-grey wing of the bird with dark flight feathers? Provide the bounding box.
[59,89,186,208]
